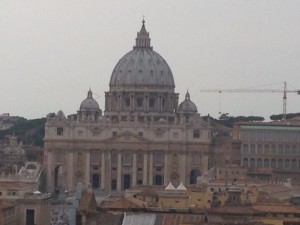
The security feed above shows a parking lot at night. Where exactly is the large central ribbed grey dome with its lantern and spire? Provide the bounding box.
[109,20,175,89]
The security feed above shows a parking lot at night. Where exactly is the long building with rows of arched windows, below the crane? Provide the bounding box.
[233,120,300,184]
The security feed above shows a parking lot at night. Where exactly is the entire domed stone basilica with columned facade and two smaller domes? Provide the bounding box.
[44,21,211,193]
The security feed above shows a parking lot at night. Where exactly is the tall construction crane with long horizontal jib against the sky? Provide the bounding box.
[200,82,300,120]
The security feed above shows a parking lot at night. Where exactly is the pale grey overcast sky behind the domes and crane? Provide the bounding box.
[0,0,300,119]
